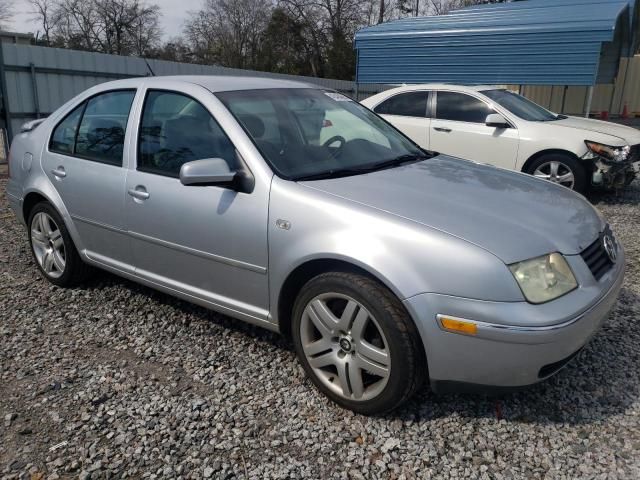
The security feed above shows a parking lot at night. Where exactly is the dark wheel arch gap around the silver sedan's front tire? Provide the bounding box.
[276,258,404,338]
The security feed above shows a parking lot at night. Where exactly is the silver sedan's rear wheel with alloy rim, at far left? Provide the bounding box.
[27,202,91,287]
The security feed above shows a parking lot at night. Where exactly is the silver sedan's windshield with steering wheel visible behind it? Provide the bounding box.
[216,88,429,180]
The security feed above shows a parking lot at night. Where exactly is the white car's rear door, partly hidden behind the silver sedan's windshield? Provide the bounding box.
[373,90,431,149]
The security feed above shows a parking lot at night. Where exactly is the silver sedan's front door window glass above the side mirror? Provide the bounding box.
[137,90,238,177]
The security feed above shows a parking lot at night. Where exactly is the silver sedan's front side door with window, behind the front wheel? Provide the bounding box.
[126,85,269,322]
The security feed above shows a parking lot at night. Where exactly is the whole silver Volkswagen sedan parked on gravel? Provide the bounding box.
[7,77,624,414]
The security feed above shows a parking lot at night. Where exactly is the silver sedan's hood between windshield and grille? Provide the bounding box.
[302,155,604,264]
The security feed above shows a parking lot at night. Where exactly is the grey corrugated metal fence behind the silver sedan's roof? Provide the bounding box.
[0,44,389,142]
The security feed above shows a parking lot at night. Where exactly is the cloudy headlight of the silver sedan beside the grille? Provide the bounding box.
[509,253,578,303]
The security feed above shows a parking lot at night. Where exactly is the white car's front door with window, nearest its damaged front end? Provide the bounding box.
[429,91,519,169]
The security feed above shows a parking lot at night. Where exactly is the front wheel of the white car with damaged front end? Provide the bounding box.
[526,153,588,193]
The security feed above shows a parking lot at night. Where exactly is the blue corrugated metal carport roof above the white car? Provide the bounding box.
[355,0,640,85]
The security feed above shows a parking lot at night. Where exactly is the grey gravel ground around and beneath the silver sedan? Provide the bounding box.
[0,171,640,480]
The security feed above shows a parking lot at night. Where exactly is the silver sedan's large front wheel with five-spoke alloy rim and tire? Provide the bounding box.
[292,272,426,415]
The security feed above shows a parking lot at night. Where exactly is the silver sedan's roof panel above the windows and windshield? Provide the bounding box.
[88,75,322,92]
